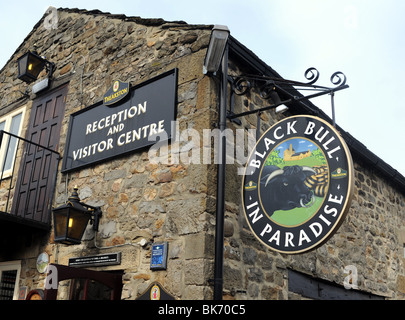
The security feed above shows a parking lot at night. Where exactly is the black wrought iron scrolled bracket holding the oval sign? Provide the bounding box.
[227,68,349,126]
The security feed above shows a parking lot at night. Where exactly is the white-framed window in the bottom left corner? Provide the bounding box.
[0,261,21,300]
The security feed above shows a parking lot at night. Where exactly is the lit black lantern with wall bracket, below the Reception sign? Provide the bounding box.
[52,187,102,245]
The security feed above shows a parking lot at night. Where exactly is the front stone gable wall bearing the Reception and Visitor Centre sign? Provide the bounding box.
[0,10,216,299]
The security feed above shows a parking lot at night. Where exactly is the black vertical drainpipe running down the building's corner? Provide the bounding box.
[214,44,228,300]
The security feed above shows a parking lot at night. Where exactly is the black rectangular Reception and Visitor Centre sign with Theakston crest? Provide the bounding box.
[62,69,177,172]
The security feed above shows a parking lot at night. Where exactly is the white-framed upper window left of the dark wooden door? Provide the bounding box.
[0,108,25,178]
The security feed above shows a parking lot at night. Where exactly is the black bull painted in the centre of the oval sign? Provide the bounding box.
[260,166,328,215]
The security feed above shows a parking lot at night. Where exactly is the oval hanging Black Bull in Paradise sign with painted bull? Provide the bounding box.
[242,116,354,254]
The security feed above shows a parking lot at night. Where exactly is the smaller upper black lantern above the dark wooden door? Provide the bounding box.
[17,51,55,83]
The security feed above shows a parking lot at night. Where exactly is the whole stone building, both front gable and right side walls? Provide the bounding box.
[0,9,405,300]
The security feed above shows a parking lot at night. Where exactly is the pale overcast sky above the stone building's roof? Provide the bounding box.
[0,0,405,175]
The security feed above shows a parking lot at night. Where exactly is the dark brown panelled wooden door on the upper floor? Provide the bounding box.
[12,85,68,224]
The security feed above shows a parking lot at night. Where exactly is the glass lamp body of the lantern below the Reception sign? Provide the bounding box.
[53,202,91,245]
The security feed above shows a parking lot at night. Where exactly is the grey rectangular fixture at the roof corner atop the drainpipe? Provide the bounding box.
[203,25,230,74]
